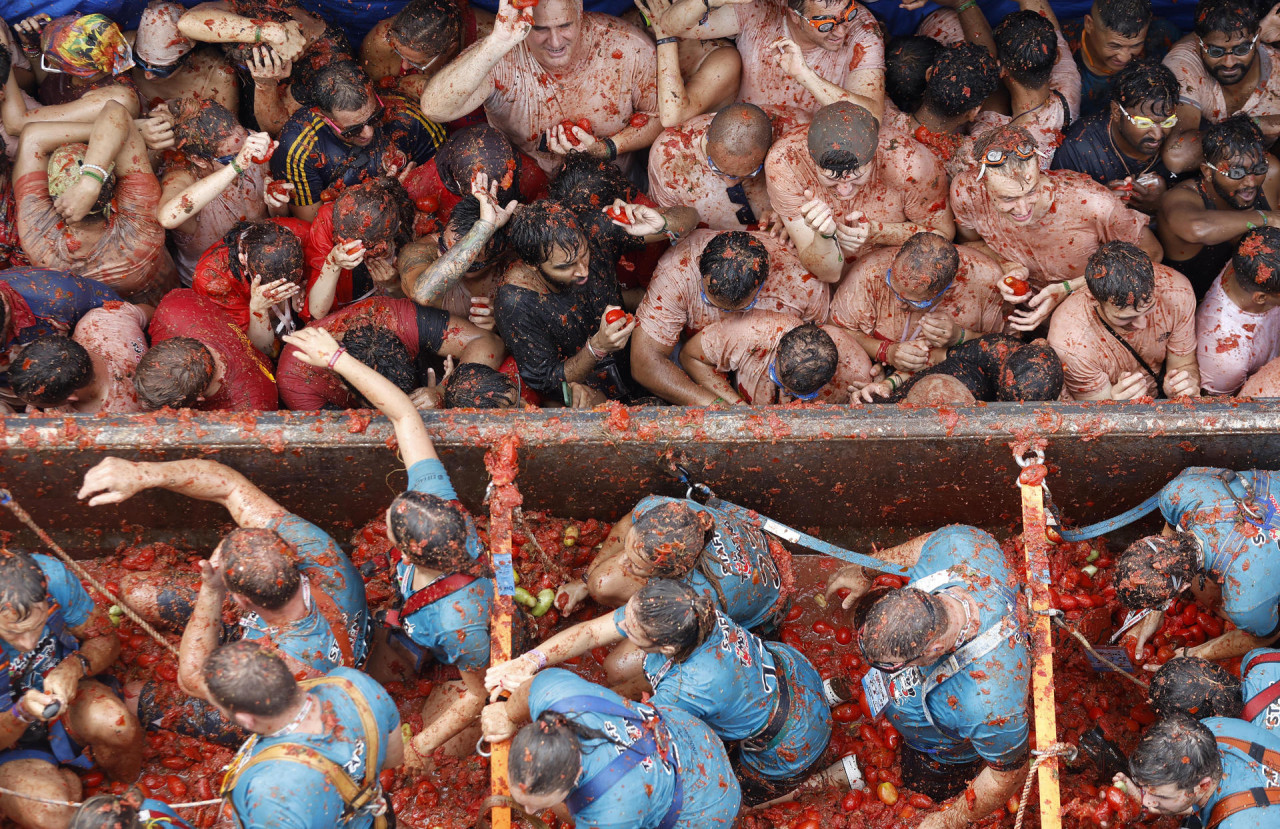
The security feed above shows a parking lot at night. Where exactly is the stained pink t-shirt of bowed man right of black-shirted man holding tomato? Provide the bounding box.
[636,230,831,345]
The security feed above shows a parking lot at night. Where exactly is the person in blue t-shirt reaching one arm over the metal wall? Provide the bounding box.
[284,328,493,770]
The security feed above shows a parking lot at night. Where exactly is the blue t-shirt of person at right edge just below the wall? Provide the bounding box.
[1160,470,1280,636]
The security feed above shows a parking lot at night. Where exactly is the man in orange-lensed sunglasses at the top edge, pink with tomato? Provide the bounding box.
[662,0,884,119]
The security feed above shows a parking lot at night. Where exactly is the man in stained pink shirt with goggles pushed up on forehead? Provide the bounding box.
[951,124,1162,331]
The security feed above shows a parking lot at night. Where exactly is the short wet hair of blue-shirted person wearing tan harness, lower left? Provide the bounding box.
[204,641,300,716]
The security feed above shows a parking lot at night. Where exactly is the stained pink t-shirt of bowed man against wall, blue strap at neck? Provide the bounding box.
[701,311,872,406]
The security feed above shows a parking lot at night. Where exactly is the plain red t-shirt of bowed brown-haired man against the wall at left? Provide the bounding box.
[148,288,279,412]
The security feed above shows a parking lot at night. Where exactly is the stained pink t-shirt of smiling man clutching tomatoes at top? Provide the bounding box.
[484,12,658,173]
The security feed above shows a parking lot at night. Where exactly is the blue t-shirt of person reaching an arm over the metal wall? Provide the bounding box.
[396,458,493,670]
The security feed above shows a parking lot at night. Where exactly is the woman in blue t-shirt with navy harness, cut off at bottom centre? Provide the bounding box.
[481,668,742,829]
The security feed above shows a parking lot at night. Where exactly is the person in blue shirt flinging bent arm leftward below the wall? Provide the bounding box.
[78,458,372,742]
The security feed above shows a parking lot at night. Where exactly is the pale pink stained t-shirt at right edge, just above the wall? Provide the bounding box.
[1196,265,1280,394]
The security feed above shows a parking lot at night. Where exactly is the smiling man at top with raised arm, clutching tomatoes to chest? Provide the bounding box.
[422,0,662,173]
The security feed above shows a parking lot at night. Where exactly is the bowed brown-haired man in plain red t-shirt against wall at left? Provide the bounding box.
[133,288,279,412]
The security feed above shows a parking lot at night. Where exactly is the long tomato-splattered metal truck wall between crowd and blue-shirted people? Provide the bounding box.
[0,402,1280,555]
